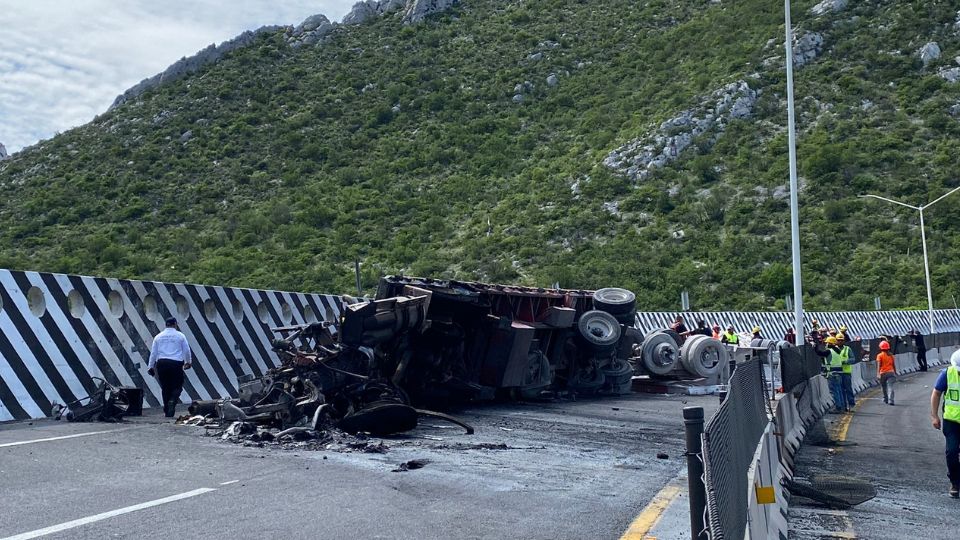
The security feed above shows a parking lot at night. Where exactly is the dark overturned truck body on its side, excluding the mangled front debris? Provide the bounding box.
[376,276,643,403]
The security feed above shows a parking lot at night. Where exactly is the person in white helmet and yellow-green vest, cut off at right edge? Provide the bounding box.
[930,351,960,499]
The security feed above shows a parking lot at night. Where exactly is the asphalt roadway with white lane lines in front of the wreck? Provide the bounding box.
[0,394,712,540]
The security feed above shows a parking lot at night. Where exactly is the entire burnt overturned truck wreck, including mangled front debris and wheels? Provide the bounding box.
[181,277,729,441]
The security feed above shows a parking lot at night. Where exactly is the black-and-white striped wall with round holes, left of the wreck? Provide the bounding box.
[0,269,342,421]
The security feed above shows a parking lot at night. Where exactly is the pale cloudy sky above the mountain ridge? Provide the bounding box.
[0,0,355,152]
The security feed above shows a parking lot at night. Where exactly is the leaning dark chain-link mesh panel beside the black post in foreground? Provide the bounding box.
[703,359,769,539]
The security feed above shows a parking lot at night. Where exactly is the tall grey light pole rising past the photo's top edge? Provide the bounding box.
[783,0,805,345]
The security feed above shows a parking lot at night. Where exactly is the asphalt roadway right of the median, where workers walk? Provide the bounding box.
[790,370,960,540]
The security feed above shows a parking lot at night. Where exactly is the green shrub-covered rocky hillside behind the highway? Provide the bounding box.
[0,0,960,310]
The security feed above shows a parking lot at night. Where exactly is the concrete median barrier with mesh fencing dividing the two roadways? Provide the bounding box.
[691,332,960,539]
